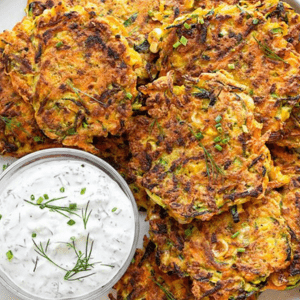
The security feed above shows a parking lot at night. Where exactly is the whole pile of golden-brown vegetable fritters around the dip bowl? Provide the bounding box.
[0,0,300,300]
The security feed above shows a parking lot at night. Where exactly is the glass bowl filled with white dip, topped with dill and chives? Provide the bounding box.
[0,148,139,300]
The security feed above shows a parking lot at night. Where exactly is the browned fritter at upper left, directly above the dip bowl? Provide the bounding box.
[6,5,141,153]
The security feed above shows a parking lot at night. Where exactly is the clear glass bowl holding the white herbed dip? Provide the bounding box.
[0,148,140,300]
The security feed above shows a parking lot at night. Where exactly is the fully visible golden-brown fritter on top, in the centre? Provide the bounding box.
[129,72,286,223]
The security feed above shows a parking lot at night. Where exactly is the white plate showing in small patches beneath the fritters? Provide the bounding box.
[0,0,300,300]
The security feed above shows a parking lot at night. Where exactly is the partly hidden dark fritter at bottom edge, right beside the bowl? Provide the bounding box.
[109,237,195,300]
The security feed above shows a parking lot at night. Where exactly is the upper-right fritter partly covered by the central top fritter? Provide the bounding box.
[150,5,300,132]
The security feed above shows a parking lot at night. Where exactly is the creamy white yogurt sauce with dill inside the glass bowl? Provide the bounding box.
[0,161,134,299]
